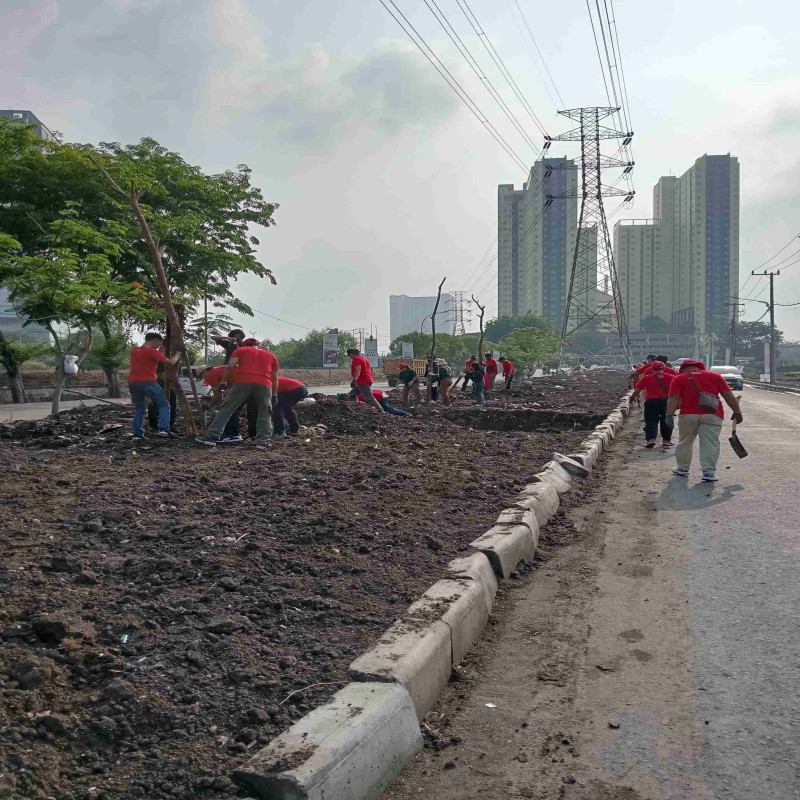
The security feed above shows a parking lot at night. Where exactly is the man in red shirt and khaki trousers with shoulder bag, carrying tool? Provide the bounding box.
[667,360,743,481]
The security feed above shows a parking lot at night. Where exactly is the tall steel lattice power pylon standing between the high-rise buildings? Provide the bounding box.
[544,107,633,367]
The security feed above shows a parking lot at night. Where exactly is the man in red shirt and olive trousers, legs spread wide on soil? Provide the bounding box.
[196,339,278,447]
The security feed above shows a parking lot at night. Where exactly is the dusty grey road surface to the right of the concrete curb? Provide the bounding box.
[387,389,800,800]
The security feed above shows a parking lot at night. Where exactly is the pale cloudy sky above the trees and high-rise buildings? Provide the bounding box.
[0,0,800,349]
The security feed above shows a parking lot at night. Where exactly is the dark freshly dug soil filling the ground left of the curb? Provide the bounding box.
[0,382,618,800]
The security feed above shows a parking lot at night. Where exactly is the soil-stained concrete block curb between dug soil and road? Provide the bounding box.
[234,392,630,800]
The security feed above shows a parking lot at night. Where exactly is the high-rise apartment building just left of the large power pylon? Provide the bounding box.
[497,158,578,329]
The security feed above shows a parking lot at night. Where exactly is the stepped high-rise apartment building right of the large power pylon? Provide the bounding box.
[614,154,739,333]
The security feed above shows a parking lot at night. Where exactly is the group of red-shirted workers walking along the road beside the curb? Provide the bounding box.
[631,355,743,481]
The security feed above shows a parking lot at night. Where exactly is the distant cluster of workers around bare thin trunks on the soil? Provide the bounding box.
[397,355,517,406]
